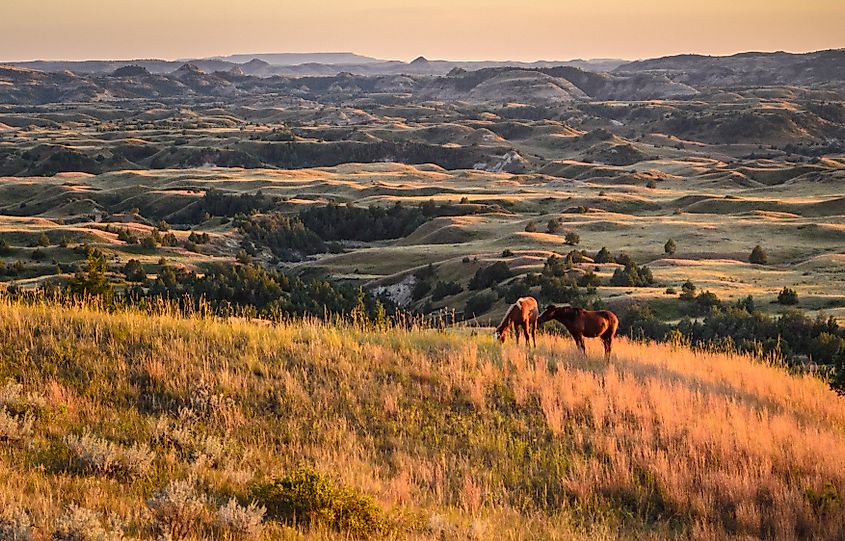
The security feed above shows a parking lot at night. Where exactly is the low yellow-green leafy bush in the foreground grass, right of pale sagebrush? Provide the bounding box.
[252,468,387,537]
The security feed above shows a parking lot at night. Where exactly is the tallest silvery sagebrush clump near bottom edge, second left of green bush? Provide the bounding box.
[147,481,207,539]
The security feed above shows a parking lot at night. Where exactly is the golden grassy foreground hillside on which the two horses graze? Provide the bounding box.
[0,301,845,539]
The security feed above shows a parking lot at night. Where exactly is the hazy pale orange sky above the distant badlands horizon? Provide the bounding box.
[0,0,845,60]
